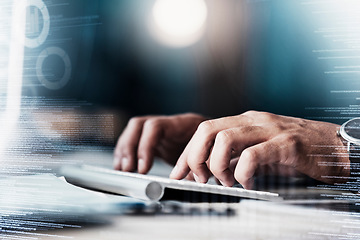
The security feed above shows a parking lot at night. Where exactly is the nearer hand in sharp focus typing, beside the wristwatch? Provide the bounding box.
[170,111,350,189]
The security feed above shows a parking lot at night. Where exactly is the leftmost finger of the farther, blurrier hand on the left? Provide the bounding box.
[114,117,147,171]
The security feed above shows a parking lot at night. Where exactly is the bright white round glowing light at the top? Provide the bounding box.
[152,0,207,47]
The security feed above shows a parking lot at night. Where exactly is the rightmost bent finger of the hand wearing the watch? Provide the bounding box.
[234,136,291,189]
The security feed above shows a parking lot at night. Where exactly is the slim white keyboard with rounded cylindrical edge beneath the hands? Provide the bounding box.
[61,165,282,201]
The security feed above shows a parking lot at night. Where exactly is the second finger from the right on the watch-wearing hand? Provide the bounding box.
[210,126,270,187]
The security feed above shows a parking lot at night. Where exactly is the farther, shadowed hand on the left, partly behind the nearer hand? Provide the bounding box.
[114,113,205,174]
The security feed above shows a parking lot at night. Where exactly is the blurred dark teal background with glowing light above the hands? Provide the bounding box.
[0,0,360,172]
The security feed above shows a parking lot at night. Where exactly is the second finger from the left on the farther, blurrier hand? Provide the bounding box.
[137,118,169,174]
